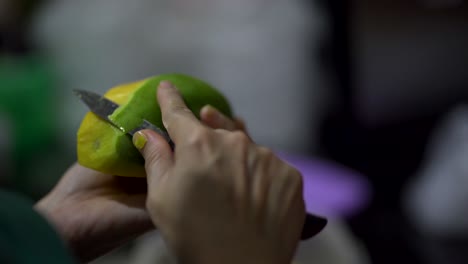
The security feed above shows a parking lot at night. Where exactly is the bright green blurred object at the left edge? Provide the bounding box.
[0,55,58,194]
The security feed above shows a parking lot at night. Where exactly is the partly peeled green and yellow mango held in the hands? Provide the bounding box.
[77,73,232,177]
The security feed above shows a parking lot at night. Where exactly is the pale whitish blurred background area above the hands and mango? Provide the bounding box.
[33,0,327,155]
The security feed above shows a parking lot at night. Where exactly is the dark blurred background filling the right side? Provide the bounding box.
[319,0,468,263]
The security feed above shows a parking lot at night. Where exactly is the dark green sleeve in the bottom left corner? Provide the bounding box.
[0,190,75,264]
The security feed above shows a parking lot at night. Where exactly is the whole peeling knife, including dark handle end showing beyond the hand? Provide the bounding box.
[73,89,328,240]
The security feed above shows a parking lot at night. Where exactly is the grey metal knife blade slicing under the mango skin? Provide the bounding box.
[73,89,174,149]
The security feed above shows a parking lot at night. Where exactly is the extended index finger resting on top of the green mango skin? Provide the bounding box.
[158,81,201,141]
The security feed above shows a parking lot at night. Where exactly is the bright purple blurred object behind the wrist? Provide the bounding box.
[277,153,371,218]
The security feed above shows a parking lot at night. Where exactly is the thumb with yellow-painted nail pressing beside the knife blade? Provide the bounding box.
[133,129,173,189]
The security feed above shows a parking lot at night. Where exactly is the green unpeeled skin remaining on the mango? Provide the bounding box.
[84,74,232,177]
